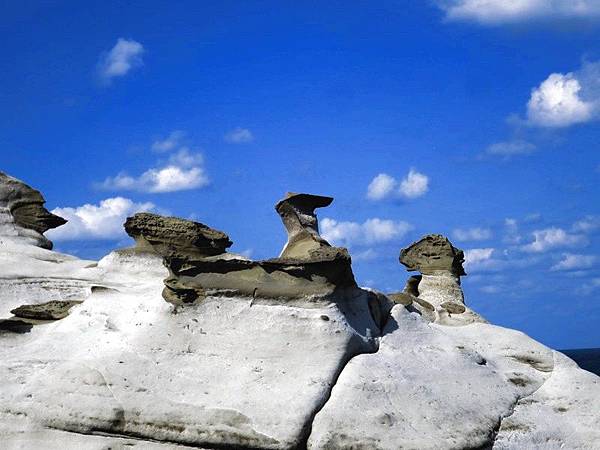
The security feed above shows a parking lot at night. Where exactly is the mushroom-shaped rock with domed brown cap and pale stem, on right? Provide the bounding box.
[400,234,483,324]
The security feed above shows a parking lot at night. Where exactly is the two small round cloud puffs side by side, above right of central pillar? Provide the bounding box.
[367,169,429,200]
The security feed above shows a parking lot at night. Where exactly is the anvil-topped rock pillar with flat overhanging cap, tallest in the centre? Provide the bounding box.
[275,192,333,258]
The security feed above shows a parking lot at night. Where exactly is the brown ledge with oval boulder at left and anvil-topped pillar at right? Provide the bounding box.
[125,194,357,305]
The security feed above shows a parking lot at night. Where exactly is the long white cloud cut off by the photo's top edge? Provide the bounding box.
[437,0,600,25]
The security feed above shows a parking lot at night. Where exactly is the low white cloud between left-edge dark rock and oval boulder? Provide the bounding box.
[46,197,154,241]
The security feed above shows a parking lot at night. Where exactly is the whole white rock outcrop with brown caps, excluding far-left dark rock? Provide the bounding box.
[0,173,600,450]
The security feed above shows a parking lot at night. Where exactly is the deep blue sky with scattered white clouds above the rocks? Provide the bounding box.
[0,0,600,348]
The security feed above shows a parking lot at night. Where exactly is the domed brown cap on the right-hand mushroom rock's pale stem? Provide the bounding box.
[400,234,466,276]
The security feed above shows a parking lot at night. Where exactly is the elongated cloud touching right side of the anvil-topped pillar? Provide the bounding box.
[320,217,413,247]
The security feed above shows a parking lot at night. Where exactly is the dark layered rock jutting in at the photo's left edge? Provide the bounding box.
[0,172,67,250]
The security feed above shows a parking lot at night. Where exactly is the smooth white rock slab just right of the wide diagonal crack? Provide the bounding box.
[309,305,564,449]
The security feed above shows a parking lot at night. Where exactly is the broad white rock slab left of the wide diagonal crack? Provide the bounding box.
[0,248,376,448]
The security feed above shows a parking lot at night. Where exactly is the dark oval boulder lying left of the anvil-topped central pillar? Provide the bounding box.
[124,213,233,257]
